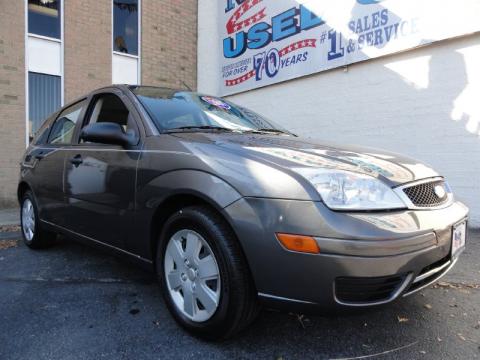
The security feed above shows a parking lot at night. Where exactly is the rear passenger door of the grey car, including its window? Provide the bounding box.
[26,100,86,226]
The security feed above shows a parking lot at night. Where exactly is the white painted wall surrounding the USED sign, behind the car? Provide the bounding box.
[198,0,480,227]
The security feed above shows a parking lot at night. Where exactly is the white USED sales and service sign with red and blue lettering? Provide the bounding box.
[218,0,480,95]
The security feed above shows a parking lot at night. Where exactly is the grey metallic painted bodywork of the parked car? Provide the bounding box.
[20,86,468,307]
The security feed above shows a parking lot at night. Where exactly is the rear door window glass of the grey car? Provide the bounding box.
[48,101,85,145]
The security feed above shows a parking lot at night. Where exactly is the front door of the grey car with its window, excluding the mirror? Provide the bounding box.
[64,89,143,249]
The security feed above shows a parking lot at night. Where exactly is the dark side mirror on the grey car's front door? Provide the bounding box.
[80,122,135,146]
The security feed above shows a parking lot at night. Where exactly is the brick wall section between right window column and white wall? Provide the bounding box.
[142,0,197,89]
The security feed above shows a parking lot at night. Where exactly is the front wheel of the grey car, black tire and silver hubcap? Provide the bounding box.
[156,206,259,340]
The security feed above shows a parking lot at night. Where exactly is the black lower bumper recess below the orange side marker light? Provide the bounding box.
[335,275,406,304]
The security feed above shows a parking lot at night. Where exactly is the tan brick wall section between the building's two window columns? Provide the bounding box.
[64,0,112,102]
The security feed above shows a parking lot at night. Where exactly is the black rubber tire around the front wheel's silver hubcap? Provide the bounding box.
[156,208,242,339]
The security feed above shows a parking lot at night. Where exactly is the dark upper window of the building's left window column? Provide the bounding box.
[28,0,60,39]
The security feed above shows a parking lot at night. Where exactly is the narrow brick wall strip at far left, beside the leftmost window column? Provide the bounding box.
[0,0,25,207]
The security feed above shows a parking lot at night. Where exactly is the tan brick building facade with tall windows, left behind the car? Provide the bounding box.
[0,0,197,207]
